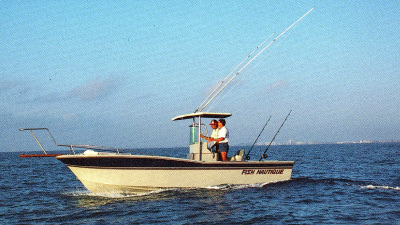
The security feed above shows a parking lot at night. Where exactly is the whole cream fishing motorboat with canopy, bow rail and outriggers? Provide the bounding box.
[20,8,314,194]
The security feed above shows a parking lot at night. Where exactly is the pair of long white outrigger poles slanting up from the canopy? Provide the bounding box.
[195,7,315,112]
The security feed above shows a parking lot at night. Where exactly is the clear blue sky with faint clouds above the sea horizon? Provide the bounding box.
[0,0,400,151]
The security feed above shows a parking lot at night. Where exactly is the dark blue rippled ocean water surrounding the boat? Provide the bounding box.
[0,143,400,224]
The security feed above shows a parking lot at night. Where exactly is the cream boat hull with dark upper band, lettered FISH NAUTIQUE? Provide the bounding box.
[57,155,294,193]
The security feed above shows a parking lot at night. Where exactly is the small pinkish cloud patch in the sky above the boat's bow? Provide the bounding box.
[69,76,122,101]
